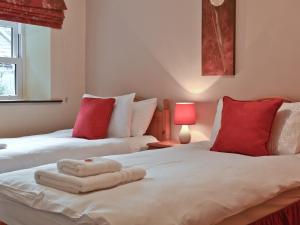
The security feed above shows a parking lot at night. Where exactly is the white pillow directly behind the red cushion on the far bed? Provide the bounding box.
[83,93,135,138]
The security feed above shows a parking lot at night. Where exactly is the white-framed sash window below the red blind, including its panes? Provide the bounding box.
[0,20,23,99]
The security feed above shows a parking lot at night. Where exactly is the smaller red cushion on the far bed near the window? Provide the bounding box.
[73,98,115,140]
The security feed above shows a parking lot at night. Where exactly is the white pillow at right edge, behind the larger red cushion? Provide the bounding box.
[268,102,300,155]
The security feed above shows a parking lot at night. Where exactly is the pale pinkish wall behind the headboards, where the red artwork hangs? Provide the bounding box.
[86,0,300,140]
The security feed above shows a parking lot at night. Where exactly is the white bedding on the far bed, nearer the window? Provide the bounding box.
[0,130,157,174]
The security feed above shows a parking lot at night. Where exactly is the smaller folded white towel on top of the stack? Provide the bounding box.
[57,158,122,177]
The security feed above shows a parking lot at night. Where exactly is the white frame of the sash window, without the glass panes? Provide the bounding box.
[0,20,24,100]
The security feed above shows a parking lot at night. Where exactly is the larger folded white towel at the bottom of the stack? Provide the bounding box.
[35,168,146,194]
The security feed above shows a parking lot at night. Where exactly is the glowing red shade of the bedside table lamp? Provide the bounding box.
[174,103,196,125]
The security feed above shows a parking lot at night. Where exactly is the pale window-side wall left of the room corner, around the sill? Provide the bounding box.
[0,0,86,137]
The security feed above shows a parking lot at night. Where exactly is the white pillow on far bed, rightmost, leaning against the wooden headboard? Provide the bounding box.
[131,98,157,137]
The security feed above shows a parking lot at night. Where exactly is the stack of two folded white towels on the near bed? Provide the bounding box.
[35,158,146,194]
